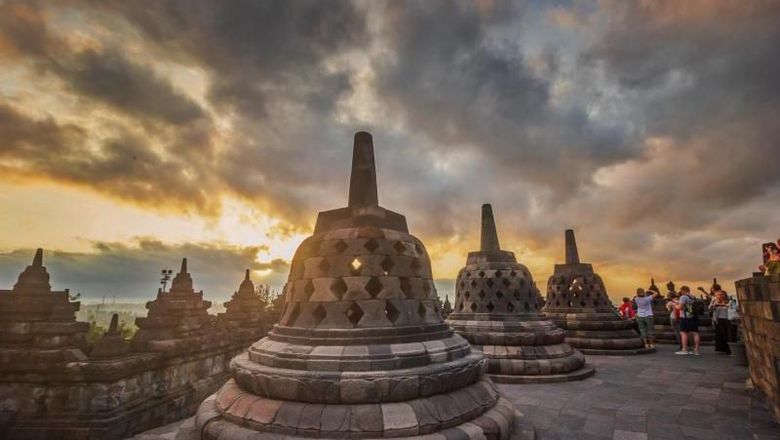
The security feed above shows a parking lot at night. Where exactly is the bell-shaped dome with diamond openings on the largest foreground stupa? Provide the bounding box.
[279,227,440,329]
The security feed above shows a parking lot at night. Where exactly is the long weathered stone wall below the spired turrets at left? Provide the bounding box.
[0,344,246,440]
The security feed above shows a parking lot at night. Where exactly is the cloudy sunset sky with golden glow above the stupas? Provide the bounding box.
[0,0,780,301]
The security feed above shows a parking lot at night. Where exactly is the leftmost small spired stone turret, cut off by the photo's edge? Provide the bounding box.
[0,249,89,374]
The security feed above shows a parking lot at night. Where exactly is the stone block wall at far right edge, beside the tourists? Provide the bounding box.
[736,275,780,420]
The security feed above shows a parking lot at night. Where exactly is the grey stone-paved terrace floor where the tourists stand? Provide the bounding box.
[498,346,780,440]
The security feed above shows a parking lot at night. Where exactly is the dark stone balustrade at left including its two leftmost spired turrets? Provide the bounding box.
[0,249,268,440]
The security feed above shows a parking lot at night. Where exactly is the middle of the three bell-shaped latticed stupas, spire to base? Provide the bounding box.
[447,204,595,383]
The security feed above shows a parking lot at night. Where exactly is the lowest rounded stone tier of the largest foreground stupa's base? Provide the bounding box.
[196,379,520,440]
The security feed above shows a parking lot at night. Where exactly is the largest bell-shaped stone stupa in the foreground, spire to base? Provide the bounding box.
[196,132,532,440]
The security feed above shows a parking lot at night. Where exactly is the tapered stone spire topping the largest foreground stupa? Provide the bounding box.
[349,131,379,208]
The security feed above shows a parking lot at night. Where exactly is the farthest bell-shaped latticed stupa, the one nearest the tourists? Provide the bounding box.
[543,229,655,355]
